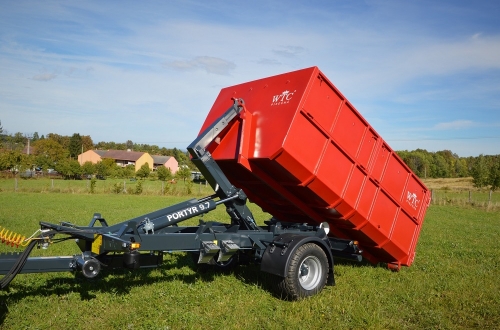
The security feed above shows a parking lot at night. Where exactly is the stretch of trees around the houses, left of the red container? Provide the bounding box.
[0,122,196,180]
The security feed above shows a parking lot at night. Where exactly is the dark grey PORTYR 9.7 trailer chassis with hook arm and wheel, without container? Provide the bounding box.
[0,99,362,300]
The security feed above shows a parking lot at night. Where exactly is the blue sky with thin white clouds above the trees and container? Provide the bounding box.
[0,0,500,157]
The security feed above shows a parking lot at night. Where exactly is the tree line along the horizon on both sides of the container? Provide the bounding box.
[0,122,500,190]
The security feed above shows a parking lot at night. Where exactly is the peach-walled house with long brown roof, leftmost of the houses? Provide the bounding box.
[78,149,154,172]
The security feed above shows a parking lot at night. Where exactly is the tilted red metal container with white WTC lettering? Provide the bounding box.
[200,67,430,266]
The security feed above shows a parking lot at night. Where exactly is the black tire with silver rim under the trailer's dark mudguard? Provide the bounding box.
[278,243,329,300]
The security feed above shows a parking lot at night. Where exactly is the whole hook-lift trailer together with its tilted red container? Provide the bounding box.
[0,67,430,300]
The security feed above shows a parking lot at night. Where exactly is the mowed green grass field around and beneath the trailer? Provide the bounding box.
[0,191,500,329]
